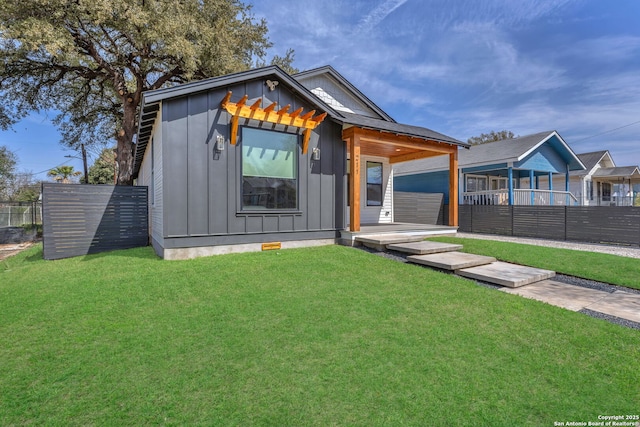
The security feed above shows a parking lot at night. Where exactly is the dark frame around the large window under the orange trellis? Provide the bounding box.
[236,126,303,216]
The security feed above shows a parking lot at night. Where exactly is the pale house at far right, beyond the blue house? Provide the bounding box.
[569,150,640,206]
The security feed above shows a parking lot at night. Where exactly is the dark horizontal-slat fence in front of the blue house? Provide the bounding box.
[458,205,640,245]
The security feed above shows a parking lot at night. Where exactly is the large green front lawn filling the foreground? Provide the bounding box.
[0,246,640,426]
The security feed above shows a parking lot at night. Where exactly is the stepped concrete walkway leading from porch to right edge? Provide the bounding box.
[355,233,640,324]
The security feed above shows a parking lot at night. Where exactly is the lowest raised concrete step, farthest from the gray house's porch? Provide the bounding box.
[456,261,556,288]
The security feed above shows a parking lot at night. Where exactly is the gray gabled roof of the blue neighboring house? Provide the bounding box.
[395,131,584,175]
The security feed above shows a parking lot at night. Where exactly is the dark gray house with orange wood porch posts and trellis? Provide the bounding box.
[134,66,467,259]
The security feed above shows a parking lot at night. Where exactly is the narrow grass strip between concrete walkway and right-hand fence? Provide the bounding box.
[429,237,640,289]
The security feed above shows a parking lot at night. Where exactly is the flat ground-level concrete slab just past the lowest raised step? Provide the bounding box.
[500,280,608,311]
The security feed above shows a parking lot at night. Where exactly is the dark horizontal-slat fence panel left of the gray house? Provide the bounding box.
[42,183,149,259]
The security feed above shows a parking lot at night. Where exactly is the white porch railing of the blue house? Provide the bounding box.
[462,189,578,206]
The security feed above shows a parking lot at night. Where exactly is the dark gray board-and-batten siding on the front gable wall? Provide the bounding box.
[156,79,346,247]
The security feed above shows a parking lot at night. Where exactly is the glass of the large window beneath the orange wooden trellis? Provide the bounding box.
[242,128,298,210]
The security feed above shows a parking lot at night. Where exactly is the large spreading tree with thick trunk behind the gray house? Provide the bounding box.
[0,0,286,184]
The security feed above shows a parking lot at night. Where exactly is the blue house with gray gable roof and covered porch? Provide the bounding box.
[394,131,584,205]
